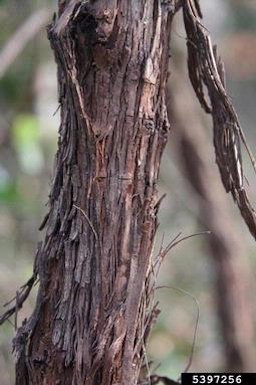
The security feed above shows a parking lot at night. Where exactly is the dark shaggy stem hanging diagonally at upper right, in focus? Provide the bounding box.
[183,0,256,238]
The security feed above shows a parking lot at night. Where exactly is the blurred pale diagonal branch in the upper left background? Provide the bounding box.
[0,8,51,79]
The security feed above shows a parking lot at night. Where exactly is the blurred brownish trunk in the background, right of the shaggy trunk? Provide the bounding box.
[168,55,255,372]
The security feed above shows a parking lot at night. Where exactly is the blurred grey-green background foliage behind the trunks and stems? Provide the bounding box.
[0,0,256,385]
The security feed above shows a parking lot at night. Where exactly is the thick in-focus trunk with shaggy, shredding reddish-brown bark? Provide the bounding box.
[14,0,175,385]
